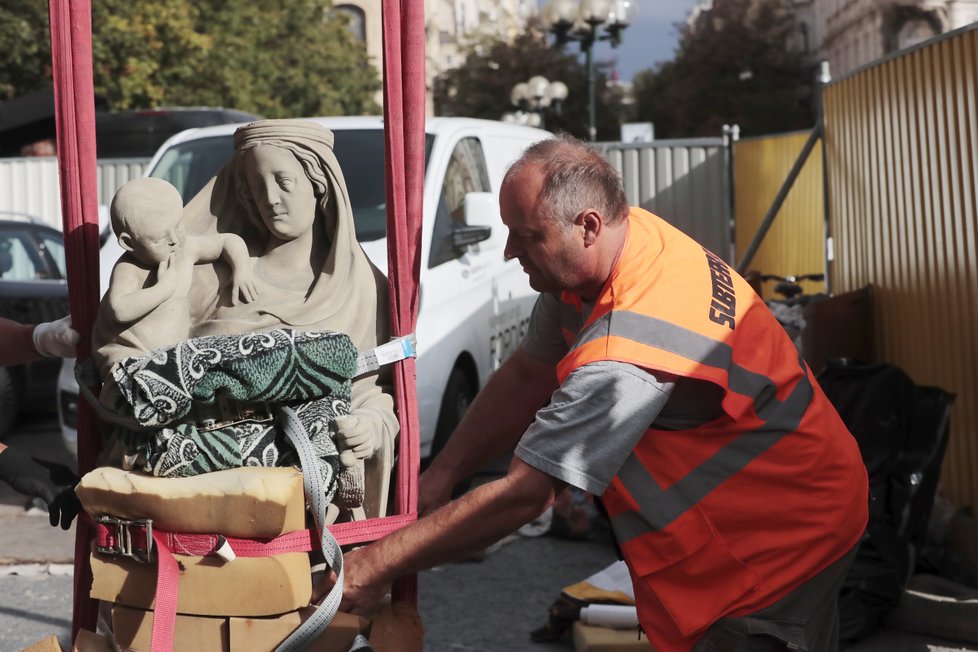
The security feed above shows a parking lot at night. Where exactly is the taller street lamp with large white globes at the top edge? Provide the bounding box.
[540,0,638,141]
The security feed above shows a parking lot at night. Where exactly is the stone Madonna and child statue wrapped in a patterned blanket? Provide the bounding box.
[94,120,398,520]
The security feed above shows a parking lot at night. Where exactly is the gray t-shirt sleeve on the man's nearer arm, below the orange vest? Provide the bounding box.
[516,361,675,495]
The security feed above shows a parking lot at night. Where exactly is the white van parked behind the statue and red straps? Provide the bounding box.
[58,117,552,458]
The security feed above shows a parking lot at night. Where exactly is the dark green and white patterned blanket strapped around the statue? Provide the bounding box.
[112,329,357,495]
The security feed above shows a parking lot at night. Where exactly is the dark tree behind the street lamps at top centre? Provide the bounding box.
[434,24,621,140]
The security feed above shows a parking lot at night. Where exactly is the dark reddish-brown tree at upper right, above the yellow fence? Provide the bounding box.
[633,0,814,138]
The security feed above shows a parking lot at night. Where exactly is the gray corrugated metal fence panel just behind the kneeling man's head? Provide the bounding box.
[595,138,733,262]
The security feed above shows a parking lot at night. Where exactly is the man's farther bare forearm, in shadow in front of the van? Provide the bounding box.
[419,348,557,514]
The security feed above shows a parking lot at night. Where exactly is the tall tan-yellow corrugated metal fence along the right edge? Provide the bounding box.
[824,26,978,508]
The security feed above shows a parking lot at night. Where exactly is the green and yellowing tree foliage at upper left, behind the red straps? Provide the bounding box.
[0,0,380,117]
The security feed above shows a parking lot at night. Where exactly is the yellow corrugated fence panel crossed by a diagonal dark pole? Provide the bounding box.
[734,131,825,299]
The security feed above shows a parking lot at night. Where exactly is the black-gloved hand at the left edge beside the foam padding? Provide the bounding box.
[0,448,79,530]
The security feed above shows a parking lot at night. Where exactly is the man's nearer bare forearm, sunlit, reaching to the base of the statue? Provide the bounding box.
[340,458,565,613]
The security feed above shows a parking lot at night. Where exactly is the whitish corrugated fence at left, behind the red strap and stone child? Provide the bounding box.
[0,156,149,229]
